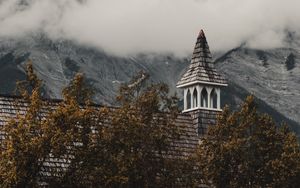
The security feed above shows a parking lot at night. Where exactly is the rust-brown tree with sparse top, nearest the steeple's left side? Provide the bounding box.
[103,73,180,187]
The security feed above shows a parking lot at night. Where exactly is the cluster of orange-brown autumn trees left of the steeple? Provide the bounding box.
[0,63,195,187]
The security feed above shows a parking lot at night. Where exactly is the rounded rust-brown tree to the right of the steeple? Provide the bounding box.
[197,96,300,187]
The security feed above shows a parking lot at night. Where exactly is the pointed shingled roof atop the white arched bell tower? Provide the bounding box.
[177,29,227,87]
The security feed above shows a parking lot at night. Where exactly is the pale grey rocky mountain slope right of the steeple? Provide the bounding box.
[216,47,300,129]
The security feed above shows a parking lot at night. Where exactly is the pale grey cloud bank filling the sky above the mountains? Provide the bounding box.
[0,0,300,55]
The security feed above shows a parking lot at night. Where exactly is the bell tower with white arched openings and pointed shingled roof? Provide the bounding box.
[177,30,228,112]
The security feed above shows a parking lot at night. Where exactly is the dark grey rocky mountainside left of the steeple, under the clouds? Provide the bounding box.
[0,35,189,104]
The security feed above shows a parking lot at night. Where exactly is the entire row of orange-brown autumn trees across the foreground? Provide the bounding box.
[0,63,300,187]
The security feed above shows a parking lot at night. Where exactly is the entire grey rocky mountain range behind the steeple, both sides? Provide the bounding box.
[0,35,300,134]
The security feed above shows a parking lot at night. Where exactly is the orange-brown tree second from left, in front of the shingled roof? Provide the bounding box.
[47,74,110,187]
